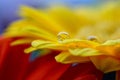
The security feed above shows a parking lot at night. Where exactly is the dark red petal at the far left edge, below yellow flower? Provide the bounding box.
[0,38,29,80]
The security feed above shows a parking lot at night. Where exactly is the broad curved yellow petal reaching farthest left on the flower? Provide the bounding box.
[3,20,56,41]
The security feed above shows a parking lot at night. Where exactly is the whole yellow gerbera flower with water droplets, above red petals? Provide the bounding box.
[3,3,120,79]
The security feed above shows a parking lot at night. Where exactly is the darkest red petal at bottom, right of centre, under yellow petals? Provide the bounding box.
[59,62,103,80]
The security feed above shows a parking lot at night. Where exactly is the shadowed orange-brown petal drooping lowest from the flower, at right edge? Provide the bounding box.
[90,56,120,73]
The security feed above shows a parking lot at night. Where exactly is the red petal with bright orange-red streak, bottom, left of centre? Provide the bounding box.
[26,53,69,80]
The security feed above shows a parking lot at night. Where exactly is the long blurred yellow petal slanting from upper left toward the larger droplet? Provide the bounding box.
[19,6,64,33]
